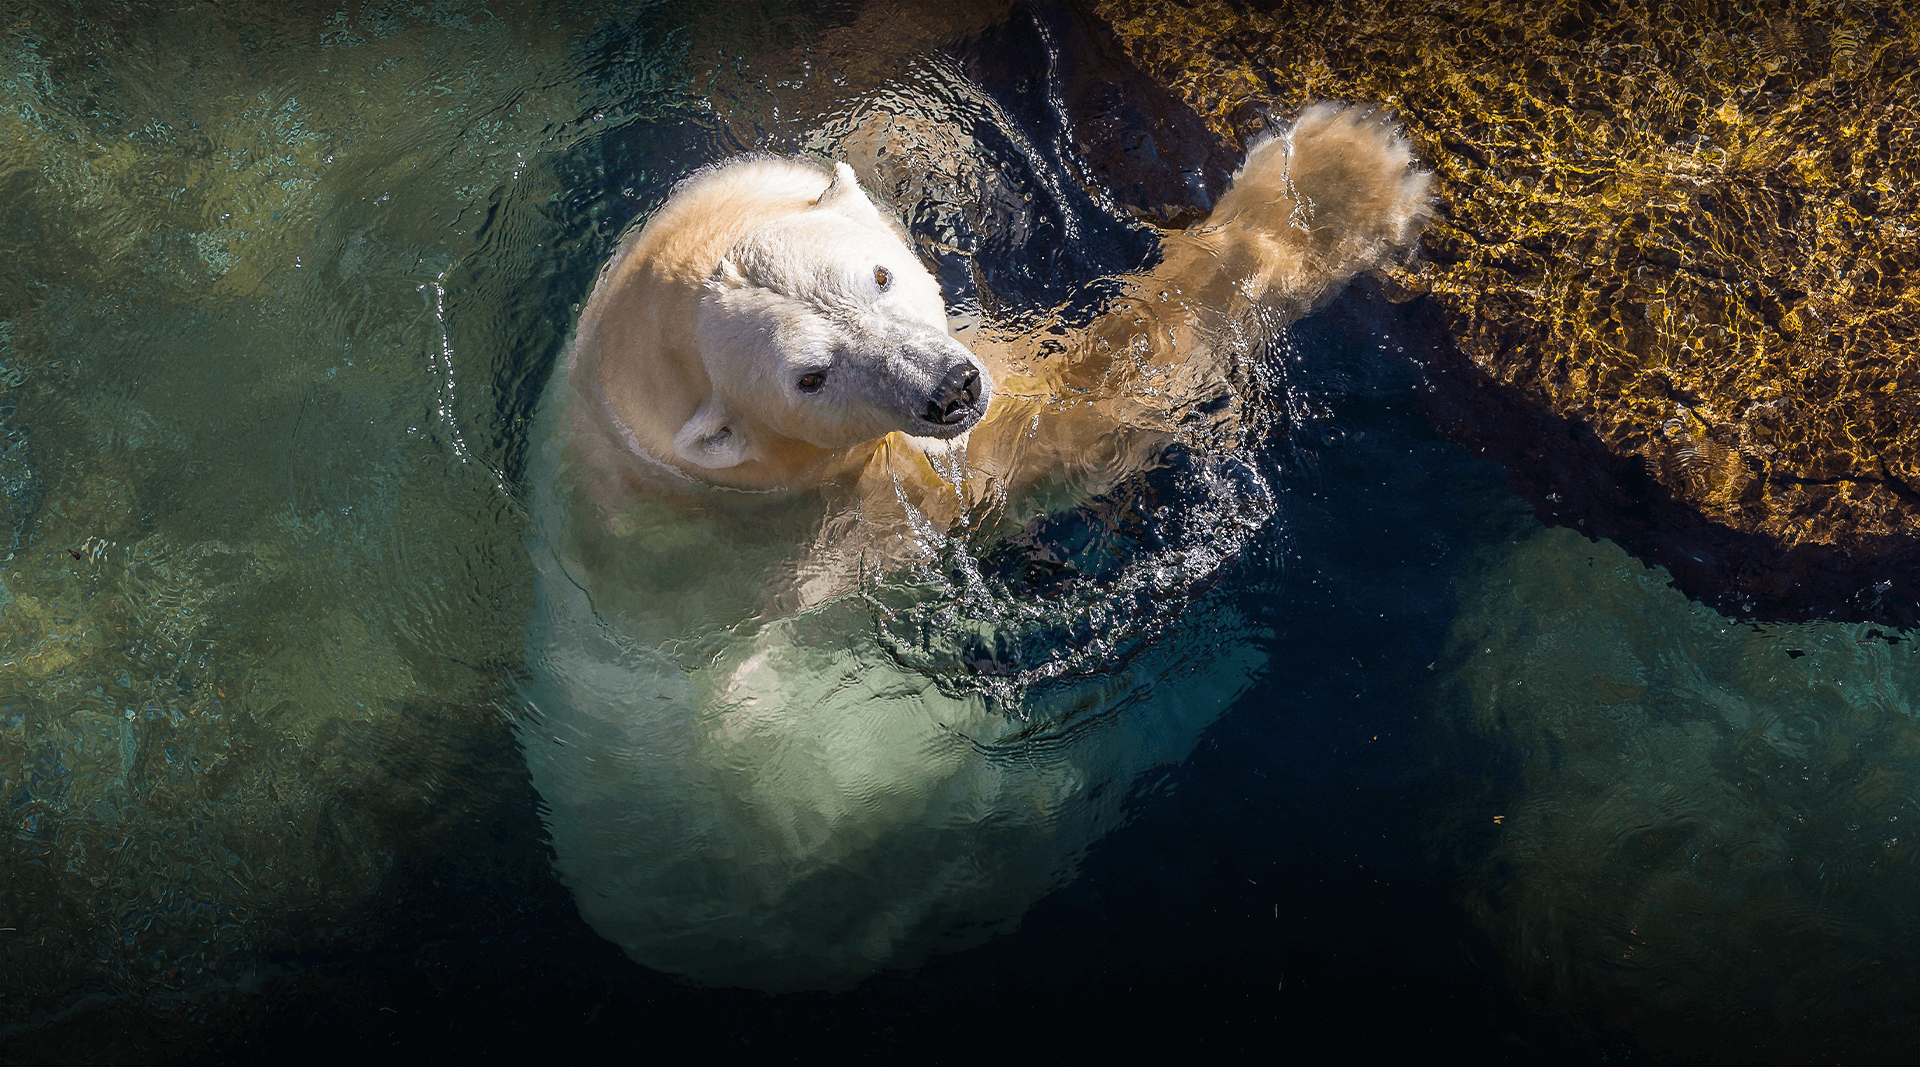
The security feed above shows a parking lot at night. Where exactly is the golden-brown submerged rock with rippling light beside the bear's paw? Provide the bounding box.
[1096,0,1920,624]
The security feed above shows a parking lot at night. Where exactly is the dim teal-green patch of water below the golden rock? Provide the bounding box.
[1440,530,1920,1055]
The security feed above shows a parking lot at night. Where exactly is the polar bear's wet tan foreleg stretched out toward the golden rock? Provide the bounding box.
[952,104,1432,514]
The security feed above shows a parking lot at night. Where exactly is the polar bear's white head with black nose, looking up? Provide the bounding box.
[674,163,993,468]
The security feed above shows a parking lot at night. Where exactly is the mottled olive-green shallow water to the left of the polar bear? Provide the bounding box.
[0,4,685,1019]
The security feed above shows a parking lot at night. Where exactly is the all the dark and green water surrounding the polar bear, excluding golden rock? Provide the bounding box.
[0,6,1920,1059]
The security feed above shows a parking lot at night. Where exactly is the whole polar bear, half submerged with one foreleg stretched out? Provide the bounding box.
[522,107,1427,990]
